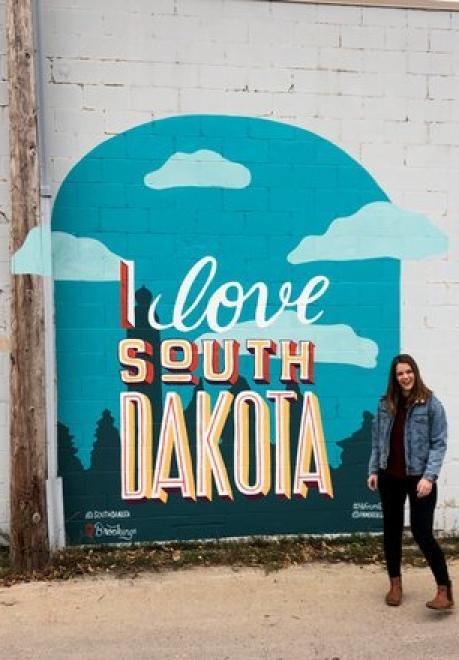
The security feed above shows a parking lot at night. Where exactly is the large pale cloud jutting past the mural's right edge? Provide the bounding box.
[287,202,448,264]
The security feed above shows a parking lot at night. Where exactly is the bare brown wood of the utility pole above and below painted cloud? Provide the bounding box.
[6,0,49,571]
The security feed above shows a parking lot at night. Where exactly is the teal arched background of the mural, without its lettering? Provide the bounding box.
[50,115,404,544]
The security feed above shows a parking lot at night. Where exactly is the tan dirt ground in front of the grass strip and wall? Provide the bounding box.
[0,561,459,660]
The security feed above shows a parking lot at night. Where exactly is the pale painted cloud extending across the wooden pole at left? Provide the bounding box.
[11,225,121,282]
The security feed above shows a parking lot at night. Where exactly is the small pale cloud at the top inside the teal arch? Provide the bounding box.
[144,149,252,190]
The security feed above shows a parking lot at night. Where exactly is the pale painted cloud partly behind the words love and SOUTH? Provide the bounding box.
[195,312,378,369]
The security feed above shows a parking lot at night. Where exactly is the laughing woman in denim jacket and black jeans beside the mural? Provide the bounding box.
[368,354,454,610]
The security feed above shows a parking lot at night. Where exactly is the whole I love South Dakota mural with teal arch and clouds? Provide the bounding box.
[13,116,446,544]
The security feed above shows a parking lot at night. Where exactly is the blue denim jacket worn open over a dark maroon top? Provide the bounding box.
[368,394,447,481]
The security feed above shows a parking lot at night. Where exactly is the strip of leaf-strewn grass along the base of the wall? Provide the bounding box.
[0,535,459,586]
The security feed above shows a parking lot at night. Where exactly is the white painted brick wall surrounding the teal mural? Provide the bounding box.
[0,0,459,529]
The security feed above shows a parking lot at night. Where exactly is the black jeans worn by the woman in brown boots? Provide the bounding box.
[378,470,449,585]
